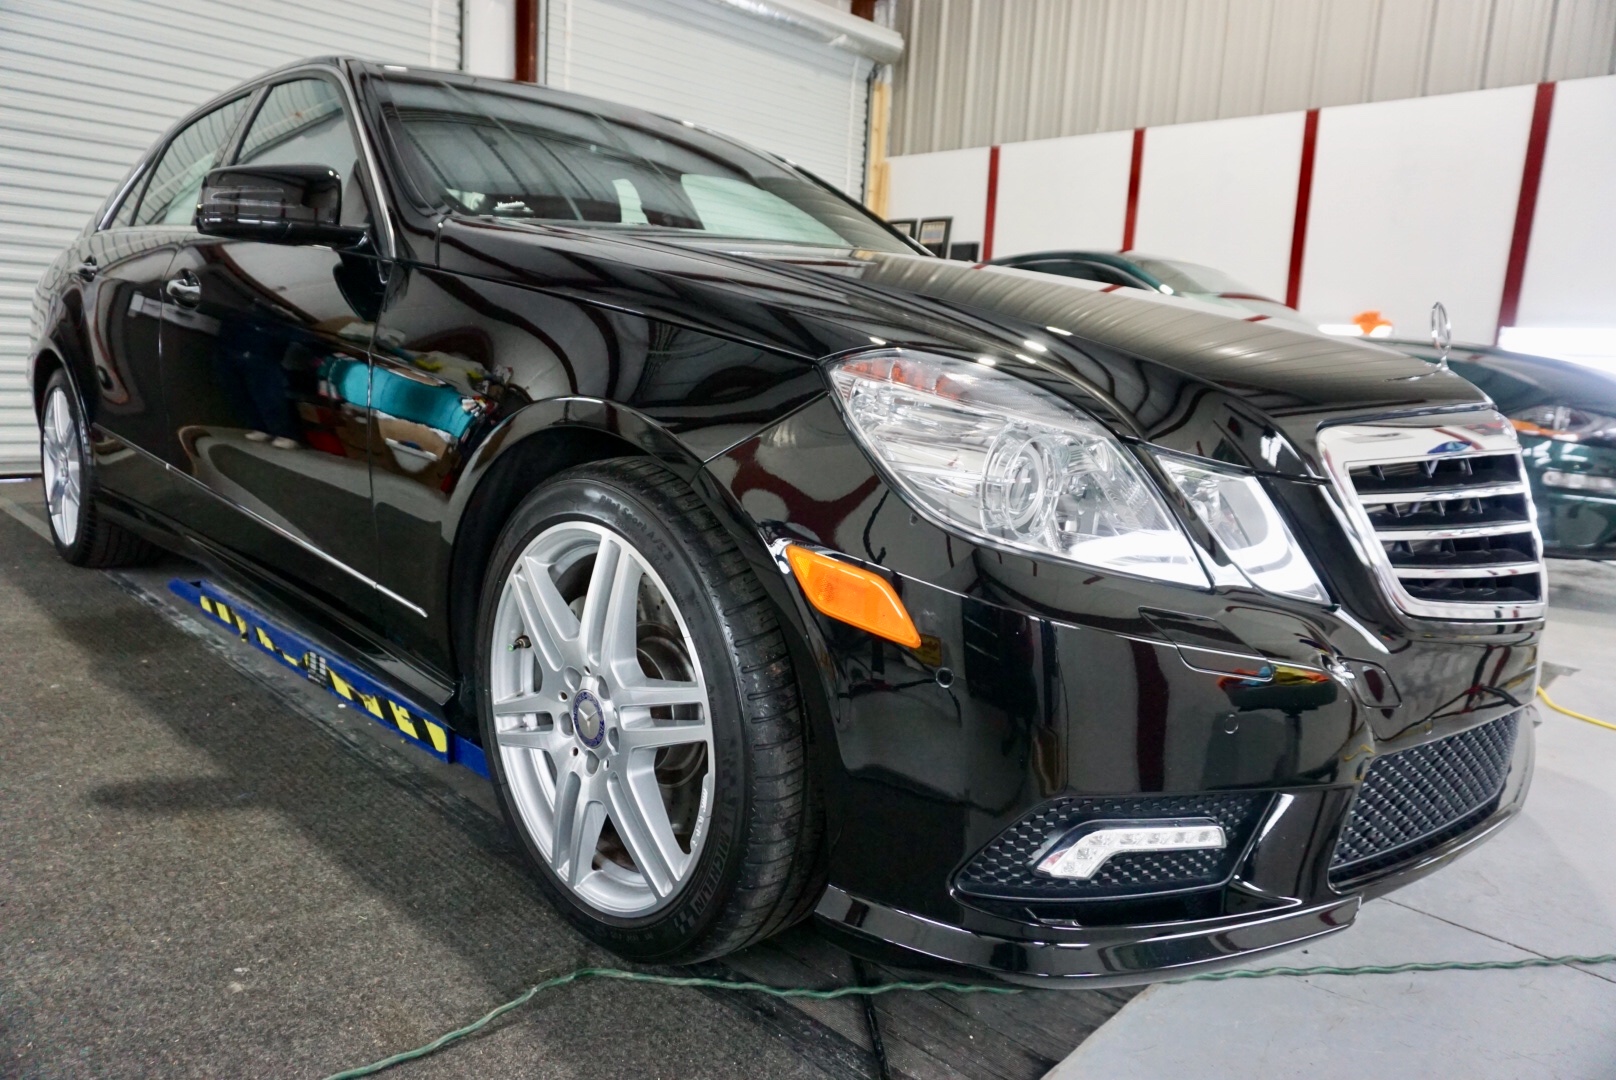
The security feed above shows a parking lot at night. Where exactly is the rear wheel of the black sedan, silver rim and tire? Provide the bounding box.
[39,370,158,567]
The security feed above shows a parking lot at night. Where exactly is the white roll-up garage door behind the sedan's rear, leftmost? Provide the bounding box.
[0,0,461,475]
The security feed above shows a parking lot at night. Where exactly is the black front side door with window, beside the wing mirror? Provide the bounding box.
[162,73,385,627]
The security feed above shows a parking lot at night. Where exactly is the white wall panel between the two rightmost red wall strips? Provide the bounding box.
[1301,86,1534,341]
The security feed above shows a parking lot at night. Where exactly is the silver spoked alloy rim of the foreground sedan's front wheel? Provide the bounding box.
[488,521,714,918]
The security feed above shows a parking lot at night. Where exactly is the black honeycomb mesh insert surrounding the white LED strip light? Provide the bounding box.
[955,794,1270,901]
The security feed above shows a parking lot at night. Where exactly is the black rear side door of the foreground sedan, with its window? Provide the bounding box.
[69,95,247,509]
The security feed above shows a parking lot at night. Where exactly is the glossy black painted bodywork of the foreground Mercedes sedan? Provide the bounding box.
[32,60,1542,981]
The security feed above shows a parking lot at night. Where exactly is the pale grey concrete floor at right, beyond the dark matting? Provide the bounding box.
[1049,563,1616,1080]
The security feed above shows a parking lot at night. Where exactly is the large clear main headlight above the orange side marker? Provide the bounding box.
[831,352,1209,587]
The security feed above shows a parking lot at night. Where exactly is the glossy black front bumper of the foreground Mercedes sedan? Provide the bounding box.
[708,403,1542,986]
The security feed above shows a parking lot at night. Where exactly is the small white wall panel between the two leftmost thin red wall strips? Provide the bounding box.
[988,131,1133,259]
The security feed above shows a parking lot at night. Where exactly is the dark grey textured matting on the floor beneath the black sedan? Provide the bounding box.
[0,483,1133,1080]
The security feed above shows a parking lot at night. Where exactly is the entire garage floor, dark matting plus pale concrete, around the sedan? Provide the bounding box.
[9,485,1616,1080]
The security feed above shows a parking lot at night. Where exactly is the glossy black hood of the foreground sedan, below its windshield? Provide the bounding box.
[438,220,1487,479]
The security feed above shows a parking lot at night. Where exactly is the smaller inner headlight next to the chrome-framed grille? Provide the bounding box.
[1155,451,1330,603]
